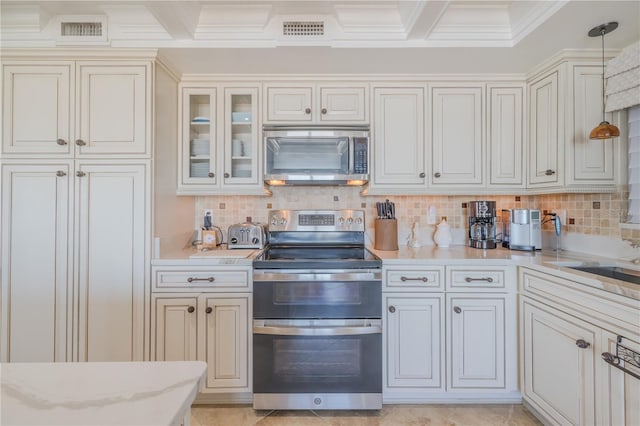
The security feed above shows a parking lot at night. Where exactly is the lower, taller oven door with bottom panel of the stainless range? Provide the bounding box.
[253,319,382,409]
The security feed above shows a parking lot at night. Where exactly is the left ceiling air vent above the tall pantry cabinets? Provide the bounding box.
[54,15,109,45]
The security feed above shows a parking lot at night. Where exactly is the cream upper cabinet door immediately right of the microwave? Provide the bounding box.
[371,87,425,192]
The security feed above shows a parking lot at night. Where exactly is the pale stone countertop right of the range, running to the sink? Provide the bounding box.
[370,246,640,300]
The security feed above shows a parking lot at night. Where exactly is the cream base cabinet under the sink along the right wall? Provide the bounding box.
[519,267,640,425]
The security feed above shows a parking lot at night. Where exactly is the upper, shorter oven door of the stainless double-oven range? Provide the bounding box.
[253,270,382,319]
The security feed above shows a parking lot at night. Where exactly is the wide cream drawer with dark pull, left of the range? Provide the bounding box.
[153,267,250,292]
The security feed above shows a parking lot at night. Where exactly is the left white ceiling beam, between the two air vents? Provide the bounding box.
[145,1,201,40]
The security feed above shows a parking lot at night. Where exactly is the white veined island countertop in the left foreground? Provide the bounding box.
[0,361,207,425]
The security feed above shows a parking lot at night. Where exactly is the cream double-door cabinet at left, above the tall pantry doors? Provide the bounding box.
[2,60,153,158]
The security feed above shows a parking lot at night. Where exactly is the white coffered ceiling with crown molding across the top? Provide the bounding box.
[0,0,640,74]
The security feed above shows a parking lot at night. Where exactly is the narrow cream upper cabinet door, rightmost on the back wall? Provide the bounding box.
[488,87,524,188]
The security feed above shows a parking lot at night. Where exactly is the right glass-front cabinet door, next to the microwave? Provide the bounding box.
[224,88,259,184]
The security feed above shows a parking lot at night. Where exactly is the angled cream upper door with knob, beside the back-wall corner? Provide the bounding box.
[529,71,564,186]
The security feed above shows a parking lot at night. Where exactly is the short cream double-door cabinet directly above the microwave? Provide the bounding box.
[264,82,369,124]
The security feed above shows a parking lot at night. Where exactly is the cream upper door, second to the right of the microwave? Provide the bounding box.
[430,87,483,186]
